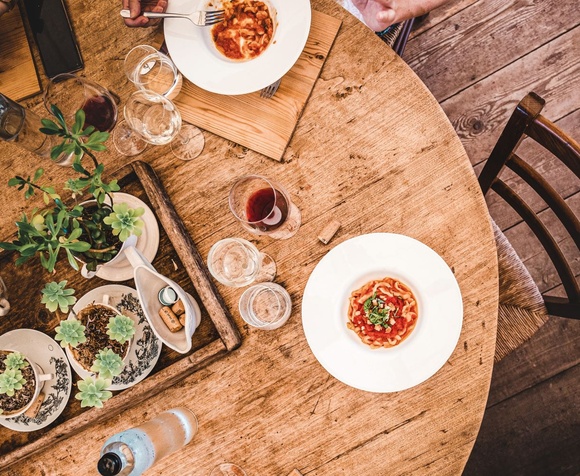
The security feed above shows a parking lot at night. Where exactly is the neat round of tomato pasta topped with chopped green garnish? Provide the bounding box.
[346,277,418,349]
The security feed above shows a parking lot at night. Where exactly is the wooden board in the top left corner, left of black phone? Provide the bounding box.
[0,5,41,101]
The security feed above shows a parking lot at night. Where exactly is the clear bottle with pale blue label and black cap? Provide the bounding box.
[97,407,197,476]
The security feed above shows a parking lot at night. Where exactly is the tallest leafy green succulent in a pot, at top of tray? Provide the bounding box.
[0,106,144,277]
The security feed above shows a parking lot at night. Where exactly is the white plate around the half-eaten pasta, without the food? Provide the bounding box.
[164,0,312,95]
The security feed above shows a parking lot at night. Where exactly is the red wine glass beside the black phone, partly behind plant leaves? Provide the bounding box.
[43,73,117,132]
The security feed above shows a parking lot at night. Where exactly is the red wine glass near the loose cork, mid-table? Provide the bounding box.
[229,175,301,240]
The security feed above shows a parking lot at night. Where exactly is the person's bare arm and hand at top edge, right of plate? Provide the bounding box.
[352,0,449,31]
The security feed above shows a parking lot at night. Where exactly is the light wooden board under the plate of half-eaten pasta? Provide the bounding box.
[175,11,341,160]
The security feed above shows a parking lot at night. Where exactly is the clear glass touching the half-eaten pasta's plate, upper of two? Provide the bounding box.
[123,45,183,99]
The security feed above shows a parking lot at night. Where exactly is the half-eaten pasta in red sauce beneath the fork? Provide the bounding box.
[211,0,274,60]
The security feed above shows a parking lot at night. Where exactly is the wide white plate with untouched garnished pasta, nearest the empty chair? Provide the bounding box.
[302,233,463,393]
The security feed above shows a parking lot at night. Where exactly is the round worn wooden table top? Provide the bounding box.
[0,0,498,476]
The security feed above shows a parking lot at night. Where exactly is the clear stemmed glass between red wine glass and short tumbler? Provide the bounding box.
[207,238,276,287]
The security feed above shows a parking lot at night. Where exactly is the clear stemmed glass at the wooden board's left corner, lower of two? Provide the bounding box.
[113,90,181,156]
